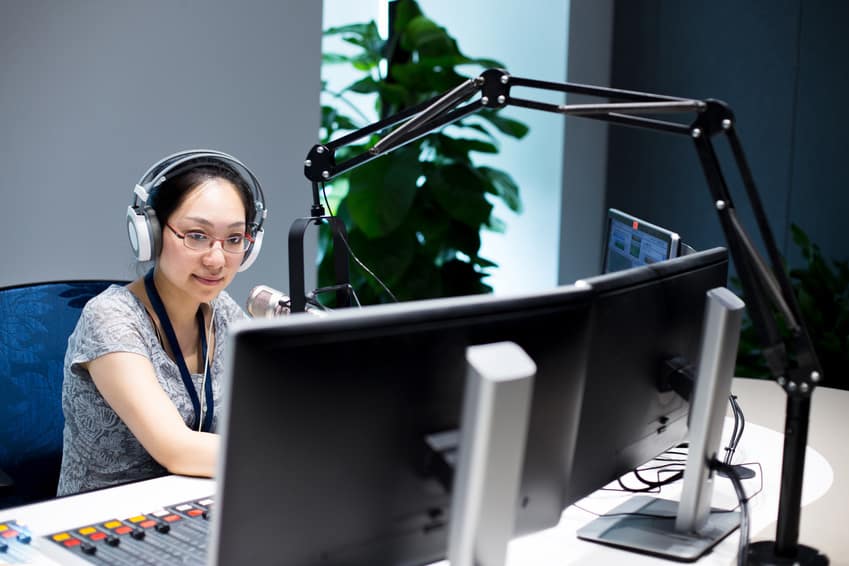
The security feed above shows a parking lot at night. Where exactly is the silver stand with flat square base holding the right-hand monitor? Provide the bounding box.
[578,287,745,561]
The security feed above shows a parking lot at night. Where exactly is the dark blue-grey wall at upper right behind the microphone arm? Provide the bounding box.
[607,0,849,270]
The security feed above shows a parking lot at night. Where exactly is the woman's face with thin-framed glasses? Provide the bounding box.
[157,178,245,303]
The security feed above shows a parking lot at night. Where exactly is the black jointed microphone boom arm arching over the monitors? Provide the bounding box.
[298,69,821,563]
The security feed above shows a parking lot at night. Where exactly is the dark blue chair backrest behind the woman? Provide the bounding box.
[0,280,126,508]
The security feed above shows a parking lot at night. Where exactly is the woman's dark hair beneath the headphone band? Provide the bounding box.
[151,163,256,229]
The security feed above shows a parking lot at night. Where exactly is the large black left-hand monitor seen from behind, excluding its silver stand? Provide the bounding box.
[210,287,590,566]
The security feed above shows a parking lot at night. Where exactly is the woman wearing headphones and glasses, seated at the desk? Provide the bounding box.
[58,150,265,495]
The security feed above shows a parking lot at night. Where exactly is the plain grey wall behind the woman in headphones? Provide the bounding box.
[0,0,321,302]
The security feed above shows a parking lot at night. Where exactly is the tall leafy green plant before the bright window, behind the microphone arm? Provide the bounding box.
[319,0,528,304]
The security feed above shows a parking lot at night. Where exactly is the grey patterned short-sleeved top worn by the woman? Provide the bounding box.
[57,285,246,495]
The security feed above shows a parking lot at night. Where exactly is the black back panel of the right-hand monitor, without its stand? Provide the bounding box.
[566,248,728,504]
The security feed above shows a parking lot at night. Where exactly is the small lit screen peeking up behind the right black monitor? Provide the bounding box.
[602,208,681,273]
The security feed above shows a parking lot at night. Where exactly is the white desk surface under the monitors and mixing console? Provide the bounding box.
[0,379,849,566]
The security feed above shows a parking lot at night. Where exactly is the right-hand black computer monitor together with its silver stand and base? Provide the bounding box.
[567,251,744,561]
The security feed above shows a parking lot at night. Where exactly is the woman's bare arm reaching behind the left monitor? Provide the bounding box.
[87,352,220,477]
